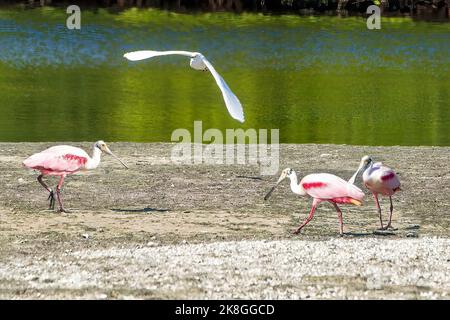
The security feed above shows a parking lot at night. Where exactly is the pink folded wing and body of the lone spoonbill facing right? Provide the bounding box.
[23,146,89,172]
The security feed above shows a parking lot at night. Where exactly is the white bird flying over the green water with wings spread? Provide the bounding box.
[124,50,244,122]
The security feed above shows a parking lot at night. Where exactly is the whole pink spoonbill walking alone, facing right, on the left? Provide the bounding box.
[23,140,128,212]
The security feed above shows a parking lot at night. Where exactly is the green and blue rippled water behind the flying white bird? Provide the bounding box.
[0,8,450,146]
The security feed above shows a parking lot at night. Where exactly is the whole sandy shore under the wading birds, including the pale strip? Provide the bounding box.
[0,143,450,298]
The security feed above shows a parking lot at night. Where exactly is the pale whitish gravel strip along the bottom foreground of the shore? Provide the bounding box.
[0,237,450,299]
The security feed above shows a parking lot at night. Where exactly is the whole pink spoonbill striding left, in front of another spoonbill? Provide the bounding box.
[264,168,364,235]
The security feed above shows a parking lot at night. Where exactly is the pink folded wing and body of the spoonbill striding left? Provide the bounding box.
[300,173,364,201]
